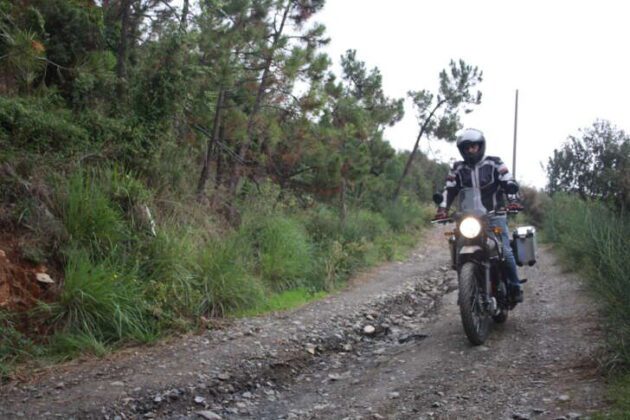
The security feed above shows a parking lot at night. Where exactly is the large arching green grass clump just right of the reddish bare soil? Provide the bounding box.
[44,250,155,347]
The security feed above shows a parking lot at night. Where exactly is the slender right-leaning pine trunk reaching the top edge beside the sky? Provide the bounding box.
[229,0,293,196]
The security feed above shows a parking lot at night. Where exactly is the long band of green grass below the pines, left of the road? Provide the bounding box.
[0,165,430,378]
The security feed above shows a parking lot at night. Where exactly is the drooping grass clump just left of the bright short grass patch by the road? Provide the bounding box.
[195,238,264,316]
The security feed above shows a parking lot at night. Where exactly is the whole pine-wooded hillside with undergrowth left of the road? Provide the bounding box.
[0,0,481,376]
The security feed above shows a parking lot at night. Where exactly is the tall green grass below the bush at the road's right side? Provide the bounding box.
[544,195,630,368]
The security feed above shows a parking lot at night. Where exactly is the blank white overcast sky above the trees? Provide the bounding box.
[315,0,630,187]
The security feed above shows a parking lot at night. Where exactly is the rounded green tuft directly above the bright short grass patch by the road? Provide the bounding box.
[242,214,313,291]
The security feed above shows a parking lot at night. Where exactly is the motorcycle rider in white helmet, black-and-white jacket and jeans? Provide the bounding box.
[434,128,523,303]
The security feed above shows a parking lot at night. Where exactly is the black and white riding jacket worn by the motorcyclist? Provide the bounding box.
[440,156,518,211]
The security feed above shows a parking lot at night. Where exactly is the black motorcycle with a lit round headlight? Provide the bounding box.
[432,188,526,345]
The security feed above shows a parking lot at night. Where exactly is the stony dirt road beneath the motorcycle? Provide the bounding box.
[0,228,606,419]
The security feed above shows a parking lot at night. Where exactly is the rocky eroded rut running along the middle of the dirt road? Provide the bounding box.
[108,262,452,418]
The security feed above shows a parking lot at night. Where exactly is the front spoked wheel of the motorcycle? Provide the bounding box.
[459,262,490,346]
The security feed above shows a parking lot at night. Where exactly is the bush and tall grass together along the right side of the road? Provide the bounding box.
[538,121,630,418]
